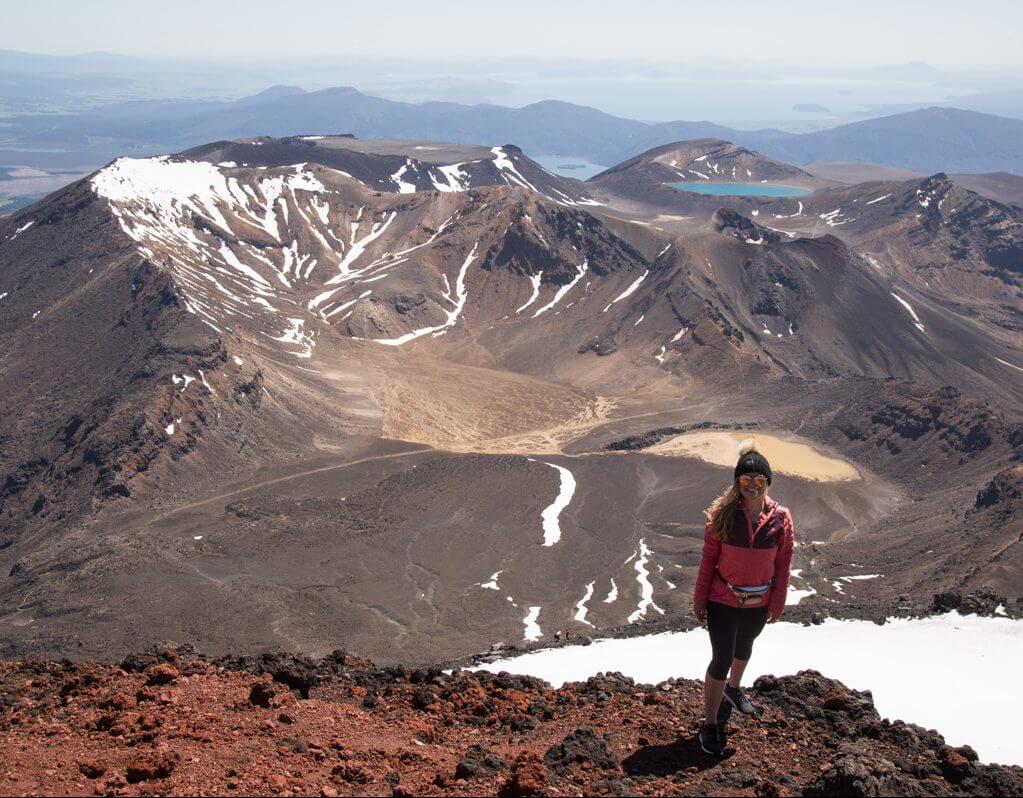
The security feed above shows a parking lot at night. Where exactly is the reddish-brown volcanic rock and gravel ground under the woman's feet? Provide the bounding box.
[0,651,1023,796]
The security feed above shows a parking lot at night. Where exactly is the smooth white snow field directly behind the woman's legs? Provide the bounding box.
[480,613,1023,765]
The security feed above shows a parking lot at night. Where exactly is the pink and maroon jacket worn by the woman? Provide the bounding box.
[693,498,795,616]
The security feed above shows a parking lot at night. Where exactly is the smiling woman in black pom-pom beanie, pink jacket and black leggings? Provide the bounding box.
[693,446,794,755]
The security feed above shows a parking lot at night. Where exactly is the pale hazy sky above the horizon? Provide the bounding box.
[6,0,1023,67]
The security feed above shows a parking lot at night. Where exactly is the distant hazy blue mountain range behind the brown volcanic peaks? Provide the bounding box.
[6,86,1023,173]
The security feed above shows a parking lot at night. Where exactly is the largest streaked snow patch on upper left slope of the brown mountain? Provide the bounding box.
[91,157,340,357]
